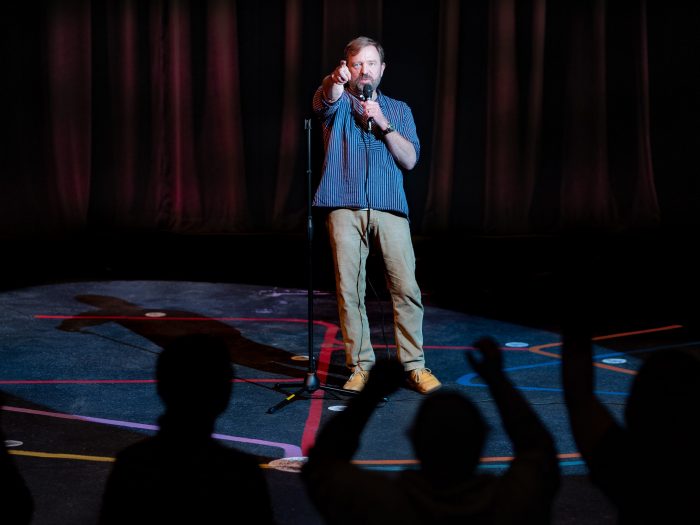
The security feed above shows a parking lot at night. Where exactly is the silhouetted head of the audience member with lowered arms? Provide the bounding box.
[156,334,233,421]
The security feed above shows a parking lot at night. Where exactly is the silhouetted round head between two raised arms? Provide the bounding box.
[409,390,488,484]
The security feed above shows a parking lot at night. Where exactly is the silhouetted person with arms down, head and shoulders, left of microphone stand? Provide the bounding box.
[100,334,274,524]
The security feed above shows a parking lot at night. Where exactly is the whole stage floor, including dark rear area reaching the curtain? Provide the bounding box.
[0,231,700,525]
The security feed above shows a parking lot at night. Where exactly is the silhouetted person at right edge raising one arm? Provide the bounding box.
[562,316,700,524]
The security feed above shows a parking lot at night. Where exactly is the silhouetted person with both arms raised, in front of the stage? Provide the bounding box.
[302,338,559,525]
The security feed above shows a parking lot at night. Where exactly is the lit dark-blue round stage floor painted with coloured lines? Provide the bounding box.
[0,268,700,524]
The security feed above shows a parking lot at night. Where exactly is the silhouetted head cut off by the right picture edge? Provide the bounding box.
[625,350,700,447]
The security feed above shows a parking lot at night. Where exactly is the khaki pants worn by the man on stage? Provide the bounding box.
[326,209,425,371]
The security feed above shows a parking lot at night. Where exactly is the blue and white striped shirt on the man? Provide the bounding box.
[313,87,420,217]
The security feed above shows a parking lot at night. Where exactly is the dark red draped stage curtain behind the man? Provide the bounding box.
[0,0,698,237]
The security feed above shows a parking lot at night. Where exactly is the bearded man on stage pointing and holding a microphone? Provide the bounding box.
[313,36,441,394]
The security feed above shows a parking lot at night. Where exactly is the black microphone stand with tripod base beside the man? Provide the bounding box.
[267,119,358,414]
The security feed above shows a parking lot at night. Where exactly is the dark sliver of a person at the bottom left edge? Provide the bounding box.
[0,395,34,525]
